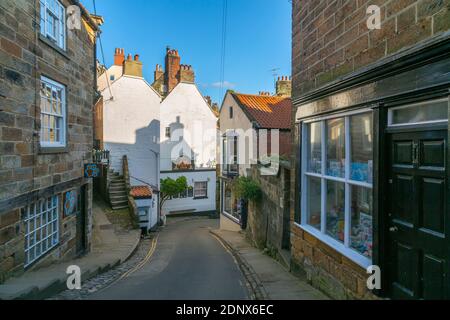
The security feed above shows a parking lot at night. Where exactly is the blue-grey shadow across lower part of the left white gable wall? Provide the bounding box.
[104,120,160,187]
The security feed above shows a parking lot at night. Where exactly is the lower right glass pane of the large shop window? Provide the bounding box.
[350,186,372,258]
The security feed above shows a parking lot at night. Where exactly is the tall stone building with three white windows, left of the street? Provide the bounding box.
[0,0,102,283]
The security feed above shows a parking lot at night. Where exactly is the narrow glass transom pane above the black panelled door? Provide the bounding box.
[391,100,448,124]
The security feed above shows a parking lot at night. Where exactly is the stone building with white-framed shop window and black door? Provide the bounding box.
[291,0,450,299]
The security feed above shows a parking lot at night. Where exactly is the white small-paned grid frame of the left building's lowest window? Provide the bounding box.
[22,195,61,268]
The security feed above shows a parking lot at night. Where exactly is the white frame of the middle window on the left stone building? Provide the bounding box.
[39,76,67,148]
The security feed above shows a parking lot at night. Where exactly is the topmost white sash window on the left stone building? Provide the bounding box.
[40,0,66,50]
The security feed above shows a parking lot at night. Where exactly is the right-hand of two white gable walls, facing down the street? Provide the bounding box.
[160,83,217,213]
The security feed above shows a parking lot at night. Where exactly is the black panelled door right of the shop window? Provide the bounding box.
[387,130,450,299]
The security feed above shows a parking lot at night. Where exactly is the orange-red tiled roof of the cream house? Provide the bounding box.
[233,93,292,129]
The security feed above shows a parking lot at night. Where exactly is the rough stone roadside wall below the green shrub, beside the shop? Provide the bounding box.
[246,165,290,257]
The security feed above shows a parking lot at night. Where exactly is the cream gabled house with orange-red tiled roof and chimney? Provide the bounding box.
[219,77,292,231]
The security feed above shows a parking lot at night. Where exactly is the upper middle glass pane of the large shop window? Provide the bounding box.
[327,118,345,178]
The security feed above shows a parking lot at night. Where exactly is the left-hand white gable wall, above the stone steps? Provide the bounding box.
[102,76,161,187]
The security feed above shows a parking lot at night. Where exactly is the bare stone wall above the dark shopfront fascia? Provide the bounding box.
[292,0,450,98]
